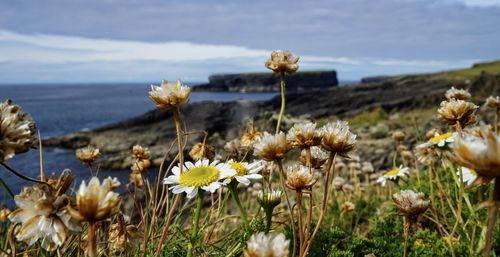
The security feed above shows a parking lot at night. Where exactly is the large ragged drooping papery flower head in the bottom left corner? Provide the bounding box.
[9,183,79,251]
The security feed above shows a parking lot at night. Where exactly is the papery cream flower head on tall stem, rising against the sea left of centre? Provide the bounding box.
[149,80,191,109]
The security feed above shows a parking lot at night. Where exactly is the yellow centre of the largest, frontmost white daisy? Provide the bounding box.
[179,166,219,187]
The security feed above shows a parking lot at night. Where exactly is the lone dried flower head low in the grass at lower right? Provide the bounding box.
[392,190,429,217]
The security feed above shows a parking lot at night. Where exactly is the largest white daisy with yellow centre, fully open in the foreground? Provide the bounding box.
[163,159,236,198]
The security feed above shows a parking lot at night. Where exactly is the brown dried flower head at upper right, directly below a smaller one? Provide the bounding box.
[438,99,478,128]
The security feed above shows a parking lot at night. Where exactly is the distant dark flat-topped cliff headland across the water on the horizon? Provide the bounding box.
[194,71,338,92]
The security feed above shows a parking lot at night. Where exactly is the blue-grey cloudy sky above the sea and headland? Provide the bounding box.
[0,0,500,84]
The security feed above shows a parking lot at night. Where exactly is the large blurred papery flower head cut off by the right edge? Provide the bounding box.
[449,130,500,180]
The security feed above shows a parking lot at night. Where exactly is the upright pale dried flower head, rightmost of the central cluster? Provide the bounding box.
[321,121,356,156]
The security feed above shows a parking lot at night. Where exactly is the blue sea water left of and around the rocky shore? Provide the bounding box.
[0,83,277,201]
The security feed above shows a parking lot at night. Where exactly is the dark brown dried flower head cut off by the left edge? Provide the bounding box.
[0,100,36,162]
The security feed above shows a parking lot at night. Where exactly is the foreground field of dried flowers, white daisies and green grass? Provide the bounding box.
[0,51,500,257]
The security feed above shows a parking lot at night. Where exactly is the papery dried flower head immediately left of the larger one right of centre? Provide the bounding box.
[286,122,321,149]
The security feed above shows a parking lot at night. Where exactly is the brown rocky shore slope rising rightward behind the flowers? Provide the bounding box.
[44,74,500,169]
